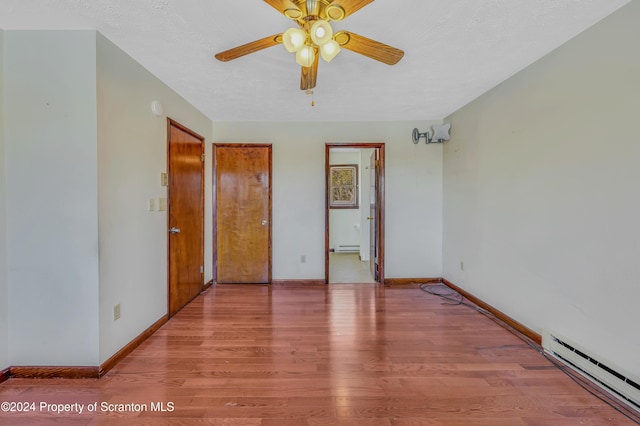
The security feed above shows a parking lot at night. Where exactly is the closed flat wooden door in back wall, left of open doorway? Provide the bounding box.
[213,144,271,284]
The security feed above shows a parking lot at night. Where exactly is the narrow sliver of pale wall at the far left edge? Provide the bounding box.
[0,30,9,371]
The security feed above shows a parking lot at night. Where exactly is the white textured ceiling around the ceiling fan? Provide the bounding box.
[0,0,630,121]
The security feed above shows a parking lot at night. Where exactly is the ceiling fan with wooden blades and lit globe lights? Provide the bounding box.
[215,0,404,90]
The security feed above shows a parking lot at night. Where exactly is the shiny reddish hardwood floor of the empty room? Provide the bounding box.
[0,284,634,426]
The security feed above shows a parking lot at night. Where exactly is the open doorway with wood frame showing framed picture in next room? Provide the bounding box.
[325,143,384,283]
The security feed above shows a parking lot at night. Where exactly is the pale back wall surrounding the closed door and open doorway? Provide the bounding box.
[213,122,442,279]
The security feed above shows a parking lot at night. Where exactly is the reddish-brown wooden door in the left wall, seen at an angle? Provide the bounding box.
[167,120,204,316]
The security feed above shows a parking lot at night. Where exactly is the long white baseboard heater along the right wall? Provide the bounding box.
[542,331,640,412]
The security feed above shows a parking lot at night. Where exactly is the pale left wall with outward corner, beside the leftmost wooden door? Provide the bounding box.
[0,31,212,369]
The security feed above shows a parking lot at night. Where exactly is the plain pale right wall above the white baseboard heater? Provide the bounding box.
[444,1,640,379]
